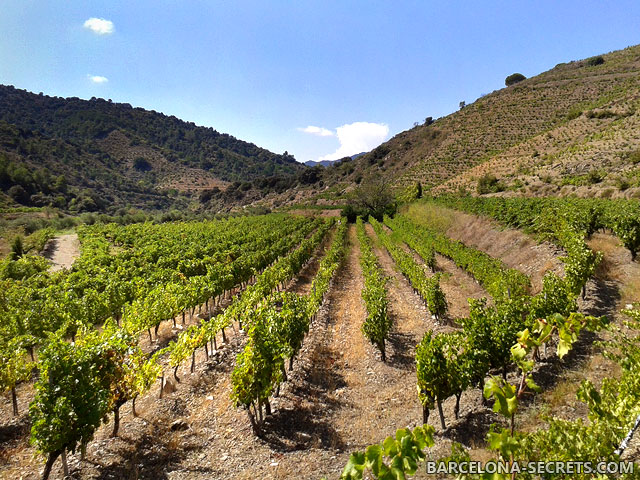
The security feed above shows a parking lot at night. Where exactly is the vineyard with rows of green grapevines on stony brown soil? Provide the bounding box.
[0,196,640,479]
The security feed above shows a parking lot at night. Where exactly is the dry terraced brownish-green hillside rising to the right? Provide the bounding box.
[292,46,640,203]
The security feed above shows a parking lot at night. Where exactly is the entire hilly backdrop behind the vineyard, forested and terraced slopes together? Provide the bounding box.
[7,46,640,211]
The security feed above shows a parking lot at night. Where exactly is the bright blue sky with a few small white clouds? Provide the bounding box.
[0,0,640,161]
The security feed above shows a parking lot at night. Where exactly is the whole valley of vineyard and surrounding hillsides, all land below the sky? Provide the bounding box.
[0,42,640,480]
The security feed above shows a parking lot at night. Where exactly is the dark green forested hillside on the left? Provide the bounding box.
[0,86,305,211]
